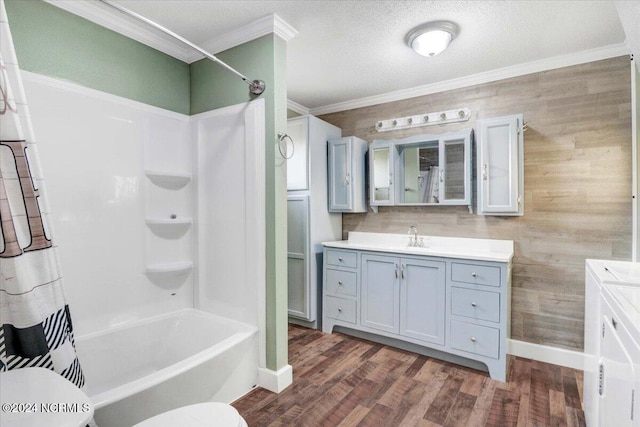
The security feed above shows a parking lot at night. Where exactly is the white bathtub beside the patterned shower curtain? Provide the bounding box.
[76,309,258,427]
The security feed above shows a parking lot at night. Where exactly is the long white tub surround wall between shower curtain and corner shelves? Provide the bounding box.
[23,72,193,335]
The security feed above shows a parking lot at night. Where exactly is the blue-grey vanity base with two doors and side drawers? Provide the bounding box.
[323,237,512,381]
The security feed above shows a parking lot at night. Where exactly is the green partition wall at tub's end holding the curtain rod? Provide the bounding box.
[191,34,287,370]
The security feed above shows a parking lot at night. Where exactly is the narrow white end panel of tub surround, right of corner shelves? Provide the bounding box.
[192,100,266,332]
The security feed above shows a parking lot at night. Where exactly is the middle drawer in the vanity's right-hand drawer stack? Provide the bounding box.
[451,286,500,322]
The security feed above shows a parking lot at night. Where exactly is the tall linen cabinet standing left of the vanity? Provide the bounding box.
[287,116,342,329]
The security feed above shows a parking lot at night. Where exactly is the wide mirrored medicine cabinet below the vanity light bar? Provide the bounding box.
[369,129,473,212]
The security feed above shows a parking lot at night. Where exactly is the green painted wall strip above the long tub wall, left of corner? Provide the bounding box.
[5,0,190,114]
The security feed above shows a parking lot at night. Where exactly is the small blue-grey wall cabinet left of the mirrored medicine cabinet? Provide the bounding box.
[327,136,368,213]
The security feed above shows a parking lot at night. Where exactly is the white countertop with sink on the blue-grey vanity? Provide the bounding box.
[322,231,513,262]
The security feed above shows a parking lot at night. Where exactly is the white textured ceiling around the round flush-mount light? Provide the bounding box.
[112,0,637,108]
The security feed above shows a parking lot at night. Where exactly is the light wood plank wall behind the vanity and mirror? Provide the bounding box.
[320,56,631,350]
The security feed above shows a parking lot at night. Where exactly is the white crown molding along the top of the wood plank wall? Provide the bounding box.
[309,43,630,116]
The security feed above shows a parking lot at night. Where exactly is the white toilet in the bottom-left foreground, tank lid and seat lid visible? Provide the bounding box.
[0,368,247,427]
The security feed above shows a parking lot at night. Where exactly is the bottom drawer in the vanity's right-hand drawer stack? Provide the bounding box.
[451,320,500,359]
